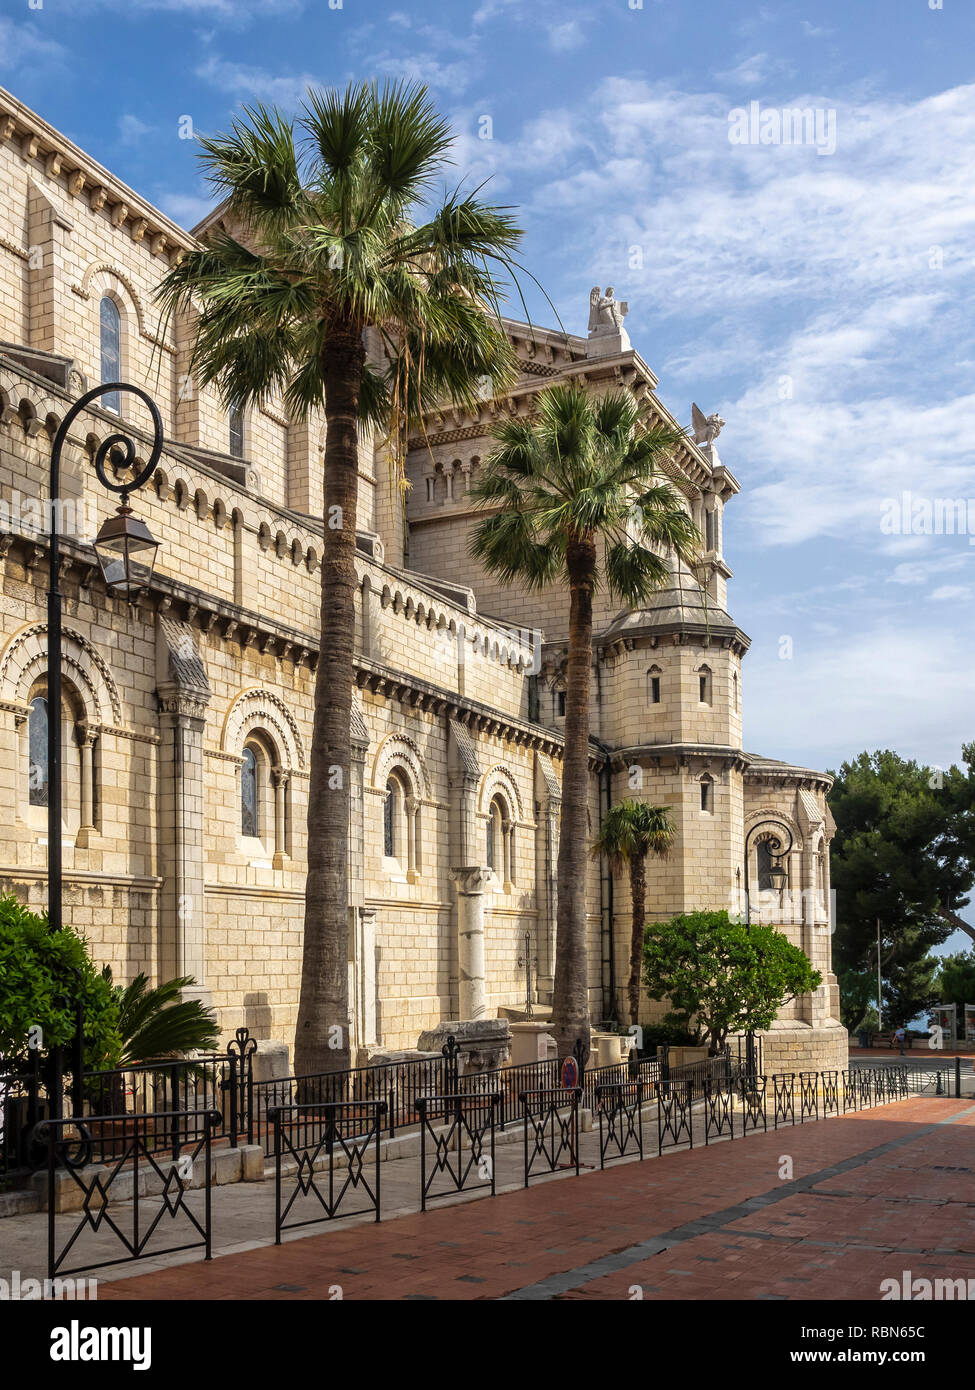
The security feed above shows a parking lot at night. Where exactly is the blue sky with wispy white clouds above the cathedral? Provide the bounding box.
[0,0,975,806]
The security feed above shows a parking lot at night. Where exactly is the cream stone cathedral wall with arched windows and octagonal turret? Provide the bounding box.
[0,90,847,1069]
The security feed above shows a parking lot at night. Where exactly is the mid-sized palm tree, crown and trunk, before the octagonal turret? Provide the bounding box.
[472,385,700,1056]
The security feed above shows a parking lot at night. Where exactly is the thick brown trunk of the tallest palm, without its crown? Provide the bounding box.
[295,327,364,1076]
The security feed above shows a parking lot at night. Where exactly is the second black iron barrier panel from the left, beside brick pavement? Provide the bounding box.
[268,1101,385,1245]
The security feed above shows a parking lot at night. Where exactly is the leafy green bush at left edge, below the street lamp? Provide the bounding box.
[0,897,121,1069]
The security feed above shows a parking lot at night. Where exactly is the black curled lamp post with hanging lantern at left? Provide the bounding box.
[47,381,163,1115]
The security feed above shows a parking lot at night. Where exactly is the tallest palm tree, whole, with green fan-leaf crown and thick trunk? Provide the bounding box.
[160,83,522,1074]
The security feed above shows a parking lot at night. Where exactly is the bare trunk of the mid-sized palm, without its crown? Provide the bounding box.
[552,539,595,1058]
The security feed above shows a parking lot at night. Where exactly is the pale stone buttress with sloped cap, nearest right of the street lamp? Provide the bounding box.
[156,617,210,1004]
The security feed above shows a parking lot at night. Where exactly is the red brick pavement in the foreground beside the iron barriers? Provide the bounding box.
[99,1098,975,1301]
